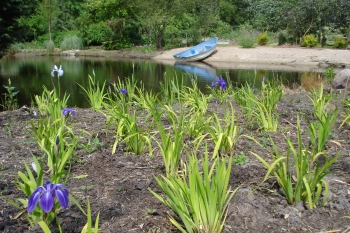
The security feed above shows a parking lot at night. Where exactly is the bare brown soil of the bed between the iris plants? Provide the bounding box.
[0,86,350,233]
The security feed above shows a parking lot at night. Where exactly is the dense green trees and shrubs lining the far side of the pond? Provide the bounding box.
[0,0,350,55]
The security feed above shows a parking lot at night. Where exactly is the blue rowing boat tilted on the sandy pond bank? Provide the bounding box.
[173,37,218,61]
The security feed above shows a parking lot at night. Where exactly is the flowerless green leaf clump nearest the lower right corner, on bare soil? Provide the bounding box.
[252,116,340,209]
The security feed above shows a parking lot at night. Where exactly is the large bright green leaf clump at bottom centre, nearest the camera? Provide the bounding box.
[150,149,238,233]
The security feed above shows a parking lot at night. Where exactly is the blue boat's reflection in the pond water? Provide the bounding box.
[174,62,216,81]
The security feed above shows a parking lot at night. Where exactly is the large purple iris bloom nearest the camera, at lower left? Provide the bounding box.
[28,181,69,213]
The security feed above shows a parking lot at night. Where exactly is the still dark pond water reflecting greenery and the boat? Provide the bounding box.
[0,57,322,108]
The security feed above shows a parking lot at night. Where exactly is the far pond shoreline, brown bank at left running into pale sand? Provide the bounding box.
[10,45,350,72]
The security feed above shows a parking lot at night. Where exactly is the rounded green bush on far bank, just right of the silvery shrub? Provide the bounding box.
[85,22,114,45]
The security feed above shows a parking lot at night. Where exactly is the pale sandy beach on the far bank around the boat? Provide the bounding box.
[152,46,350,71]
